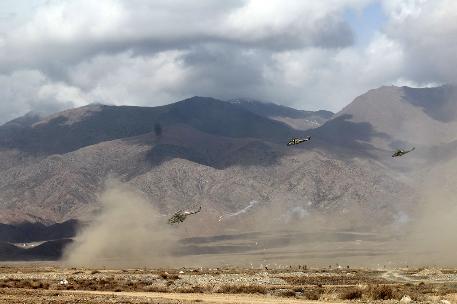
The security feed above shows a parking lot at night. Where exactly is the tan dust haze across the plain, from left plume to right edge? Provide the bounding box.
[65,160,457,267]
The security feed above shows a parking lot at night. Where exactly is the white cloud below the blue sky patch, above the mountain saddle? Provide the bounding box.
[256,33,403,110]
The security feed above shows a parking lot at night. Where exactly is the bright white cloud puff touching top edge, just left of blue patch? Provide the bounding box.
[223,0,368,48]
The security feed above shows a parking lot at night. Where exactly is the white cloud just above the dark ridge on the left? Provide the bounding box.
[69,51,188,105]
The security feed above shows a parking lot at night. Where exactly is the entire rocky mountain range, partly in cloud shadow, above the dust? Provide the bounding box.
[0,87,455,232]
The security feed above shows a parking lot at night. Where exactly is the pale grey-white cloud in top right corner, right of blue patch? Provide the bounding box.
[384,0,457,83]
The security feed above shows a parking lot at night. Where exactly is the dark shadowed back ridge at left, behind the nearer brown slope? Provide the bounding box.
[0,97,296,155]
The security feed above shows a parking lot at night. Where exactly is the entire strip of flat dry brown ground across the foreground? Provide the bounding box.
[0,264,457,304]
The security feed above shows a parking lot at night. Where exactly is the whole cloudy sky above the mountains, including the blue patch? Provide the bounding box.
[0,0,457,123]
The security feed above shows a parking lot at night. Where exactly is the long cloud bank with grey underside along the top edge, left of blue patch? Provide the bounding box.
[0,0,354,68]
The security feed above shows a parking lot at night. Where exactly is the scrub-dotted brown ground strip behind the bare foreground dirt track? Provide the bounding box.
[0,267,457,303]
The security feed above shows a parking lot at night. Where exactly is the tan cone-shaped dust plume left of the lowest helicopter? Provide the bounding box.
[64,180,176,267]
